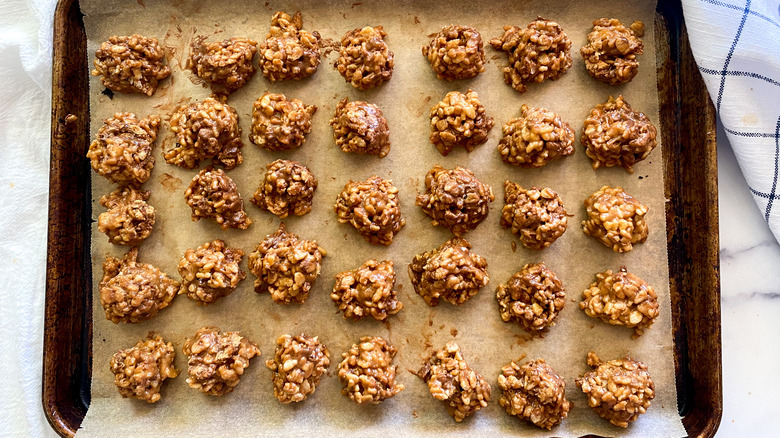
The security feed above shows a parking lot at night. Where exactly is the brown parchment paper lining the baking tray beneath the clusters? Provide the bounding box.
[79,0,685,438]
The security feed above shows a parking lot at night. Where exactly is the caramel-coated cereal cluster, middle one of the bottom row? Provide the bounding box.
[339,336,404,404]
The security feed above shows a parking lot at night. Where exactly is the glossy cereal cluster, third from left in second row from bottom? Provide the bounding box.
[249,223,325,304]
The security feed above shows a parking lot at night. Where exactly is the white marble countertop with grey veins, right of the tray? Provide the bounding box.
[716,120,780,437]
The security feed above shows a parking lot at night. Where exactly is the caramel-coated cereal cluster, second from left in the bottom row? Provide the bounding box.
[182,327,260,396]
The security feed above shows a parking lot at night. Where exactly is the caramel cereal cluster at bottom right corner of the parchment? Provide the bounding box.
[575,351,655,427]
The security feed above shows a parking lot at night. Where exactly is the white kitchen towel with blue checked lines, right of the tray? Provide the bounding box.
[683,0,780,241]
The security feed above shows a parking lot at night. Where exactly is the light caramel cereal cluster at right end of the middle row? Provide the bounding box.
[582,186,648,252]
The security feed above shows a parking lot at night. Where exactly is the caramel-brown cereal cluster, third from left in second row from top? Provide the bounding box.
[249,93,317,151]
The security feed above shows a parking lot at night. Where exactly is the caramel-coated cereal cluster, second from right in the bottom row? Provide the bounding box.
[498,358,571,430]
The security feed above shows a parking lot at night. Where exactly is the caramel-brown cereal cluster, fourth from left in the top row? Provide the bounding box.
[335,26,394,90]
